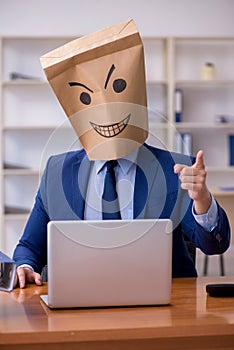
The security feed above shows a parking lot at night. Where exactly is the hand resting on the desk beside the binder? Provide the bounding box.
[14,267,42,288]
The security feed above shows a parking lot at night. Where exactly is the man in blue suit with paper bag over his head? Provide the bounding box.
[14,21,230,288]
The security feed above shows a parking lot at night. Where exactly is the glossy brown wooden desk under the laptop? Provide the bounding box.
[0,277,234,350]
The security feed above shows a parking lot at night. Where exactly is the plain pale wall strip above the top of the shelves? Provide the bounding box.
[0,0,234,36]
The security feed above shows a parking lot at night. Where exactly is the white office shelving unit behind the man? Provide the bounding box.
[0,37,234,255]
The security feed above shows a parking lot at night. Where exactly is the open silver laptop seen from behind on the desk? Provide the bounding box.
[41,219,172,308]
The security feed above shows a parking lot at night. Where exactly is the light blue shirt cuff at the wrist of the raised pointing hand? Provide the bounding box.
[192,195,218,232]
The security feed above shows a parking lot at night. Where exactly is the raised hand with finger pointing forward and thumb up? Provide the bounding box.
[174,151,211,214]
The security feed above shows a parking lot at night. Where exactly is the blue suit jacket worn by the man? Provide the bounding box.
[14,144,230,277]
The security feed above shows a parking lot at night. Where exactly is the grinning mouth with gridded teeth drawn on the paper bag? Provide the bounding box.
[90,114,131,137]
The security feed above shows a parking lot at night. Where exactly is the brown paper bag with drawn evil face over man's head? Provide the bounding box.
[40,20,148,160]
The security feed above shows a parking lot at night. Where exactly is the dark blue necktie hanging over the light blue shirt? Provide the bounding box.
[102,160,121,220]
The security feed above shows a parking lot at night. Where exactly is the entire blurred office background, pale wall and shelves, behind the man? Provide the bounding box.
[0,0,234,275]
